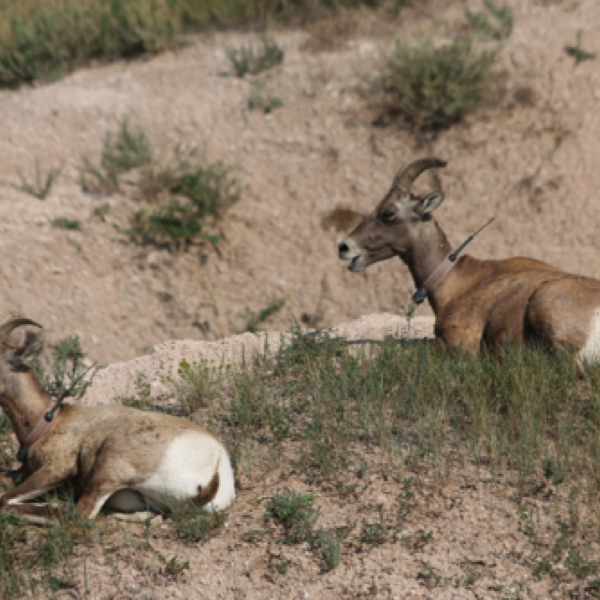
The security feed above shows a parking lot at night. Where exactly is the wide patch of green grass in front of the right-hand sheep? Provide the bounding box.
[202,335,600,504]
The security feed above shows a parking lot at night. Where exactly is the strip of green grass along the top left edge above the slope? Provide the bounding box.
[0,0,390,88]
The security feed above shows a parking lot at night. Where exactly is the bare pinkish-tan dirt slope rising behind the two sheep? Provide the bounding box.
[0,0,600,364]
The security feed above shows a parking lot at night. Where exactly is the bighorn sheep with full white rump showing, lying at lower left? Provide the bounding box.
[0,313,235,523]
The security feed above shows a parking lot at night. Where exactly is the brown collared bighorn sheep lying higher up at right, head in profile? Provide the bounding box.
[338,158,600,362]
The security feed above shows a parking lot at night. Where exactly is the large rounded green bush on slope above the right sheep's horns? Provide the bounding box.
[384,36,499,127]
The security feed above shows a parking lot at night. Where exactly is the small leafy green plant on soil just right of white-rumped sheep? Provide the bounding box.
[263,488,319,544]
